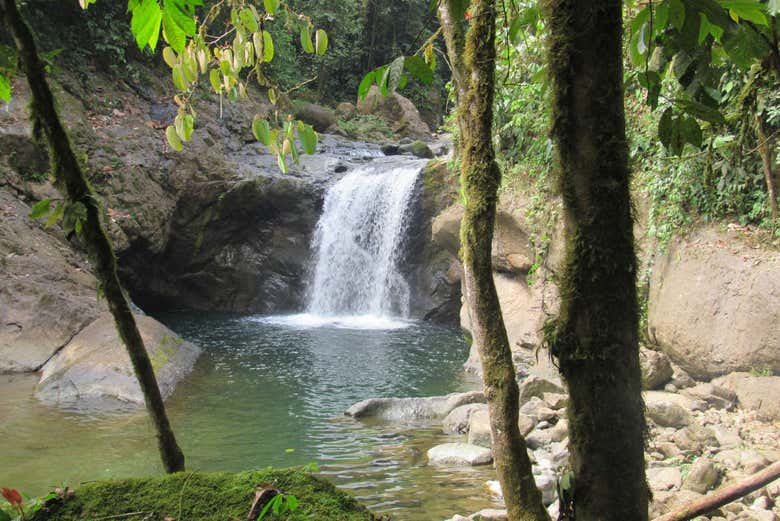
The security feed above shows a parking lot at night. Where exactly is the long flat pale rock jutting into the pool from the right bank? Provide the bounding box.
[345,391,485,421]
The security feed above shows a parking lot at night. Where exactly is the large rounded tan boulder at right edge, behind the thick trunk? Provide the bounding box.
[648,228,780,380]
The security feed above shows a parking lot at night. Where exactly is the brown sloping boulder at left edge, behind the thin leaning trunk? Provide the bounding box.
[0,189,105,373]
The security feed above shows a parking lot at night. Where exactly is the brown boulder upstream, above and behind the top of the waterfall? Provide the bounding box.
[357,85,431,140]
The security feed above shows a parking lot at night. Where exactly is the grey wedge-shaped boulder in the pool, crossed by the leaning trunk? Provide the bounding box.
[36,314,200,405]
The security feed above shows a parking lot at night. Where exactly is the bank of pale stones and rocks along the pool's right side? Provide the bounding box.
[347,355,780,521]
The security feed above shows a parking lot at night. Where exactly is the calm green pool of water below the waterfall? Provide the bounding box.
[0,314,495,521]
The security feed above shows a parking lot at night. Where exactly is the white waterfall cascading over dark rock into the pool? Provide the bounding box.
[308,161,422,318]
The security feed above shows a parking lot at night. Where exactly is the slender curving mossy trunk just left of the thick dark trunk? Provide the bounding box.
[450,0,549,521]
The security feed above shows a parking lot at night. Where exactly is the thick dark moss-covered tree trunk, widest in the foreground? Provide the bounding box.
[545,0,648,521]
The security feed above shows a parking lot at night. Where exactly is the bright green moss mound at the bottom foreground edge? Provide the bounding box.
[31,469,382,521]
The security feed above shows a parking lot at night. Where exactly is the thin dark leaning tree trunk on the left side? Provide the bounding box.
[0,0,184,472]
